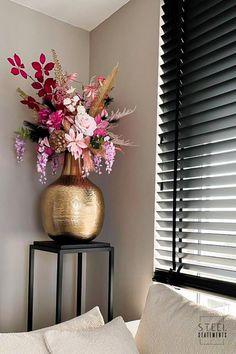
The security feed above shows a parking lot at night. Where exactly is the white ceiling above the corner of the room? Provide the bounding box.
[11,0,129,31]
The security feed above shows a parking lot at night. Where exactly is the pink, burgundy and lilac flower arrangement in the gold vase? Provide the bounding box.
[8,50,135,183]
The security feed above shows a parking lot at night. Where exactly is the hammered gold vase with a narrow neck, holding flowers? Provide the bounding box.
[41,152,104,242]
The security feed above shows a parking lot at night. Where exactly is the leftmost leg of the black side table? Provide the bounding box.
[27,245,34,331]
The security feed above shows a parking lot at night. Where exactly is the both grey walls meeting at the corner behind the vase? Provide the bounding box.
[0,0,159,332]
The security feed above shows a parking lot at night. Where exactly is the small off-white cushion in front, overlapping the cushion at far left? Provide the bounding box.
[45,317,139,354]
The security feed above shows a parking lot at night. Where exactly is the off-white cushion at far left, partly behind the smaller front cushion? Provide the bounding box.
[0,307,104,354]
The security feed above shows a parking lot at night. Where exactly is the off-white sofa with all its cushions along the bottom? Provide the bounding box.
[0,284,236,354]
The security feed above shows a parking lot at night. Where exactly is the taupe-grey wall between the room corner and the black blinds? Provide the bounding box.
[87,0,159,320]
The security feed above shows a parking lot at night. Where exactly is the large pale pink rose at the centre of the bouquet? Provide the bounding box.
[75,106,97,136]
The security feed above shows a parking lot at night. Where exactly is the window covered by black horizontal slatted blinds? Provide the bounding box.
[154,0,236,296]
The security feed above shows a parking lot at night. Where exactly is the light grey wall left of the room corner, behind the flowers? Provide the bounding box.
[0,0,89,332]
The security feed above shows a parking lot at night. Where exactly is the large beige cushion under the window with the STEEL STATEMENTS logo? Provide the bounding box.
[136,284,236,354]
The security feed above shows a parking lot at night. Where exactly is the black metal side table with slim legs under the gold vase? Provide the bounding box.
[27,241,114,331]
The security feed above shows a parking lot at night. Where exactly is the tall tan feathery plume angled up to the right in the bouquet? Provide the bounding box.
[89,64,118,117]
